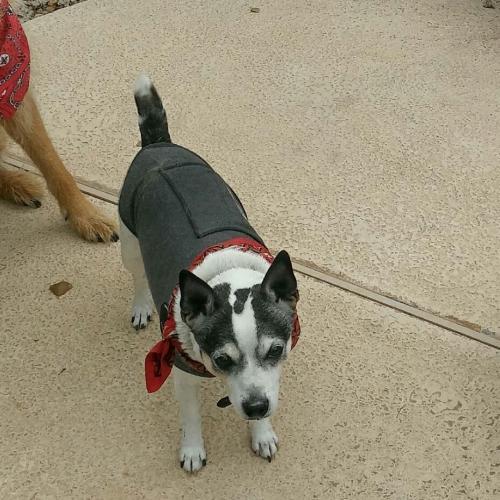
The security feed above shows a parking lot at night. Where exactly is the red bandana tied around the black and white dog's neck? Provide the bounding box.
[145,238,300,392]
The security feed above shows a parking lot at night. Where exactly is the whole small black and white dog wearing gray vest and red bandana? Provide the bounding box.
[119,76,300,472]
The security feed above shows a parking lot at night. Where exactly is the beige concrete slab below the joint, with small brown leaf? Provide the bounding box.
[0,197,500,500]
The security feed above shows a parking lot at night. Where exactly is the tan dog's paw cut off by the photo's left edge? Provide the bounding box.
[0,169,43,208]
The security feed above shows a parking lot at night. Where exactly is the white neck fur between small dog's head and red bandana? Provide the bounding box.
[174,248,270,362]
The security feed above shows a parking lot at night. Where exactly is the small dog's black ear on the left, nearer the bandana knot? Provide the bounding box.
[179,270,215,326]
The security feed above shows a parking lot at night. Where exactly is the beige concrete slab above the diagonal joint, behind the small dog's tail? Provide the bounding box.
[12,0,500,332]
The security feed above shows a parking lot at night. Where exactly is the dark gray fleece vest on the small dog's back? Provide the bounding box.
[119,143,263,336]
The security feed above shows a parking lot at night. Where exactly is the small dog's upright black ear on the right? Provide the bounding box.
[261,250,299,309]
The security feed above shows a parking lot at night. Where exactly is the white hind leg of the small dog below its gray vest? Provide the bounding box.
[120,219,153,330]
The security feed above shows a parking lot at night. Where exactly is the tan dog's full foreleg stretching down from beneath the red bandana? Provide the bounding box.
[0,92,118,242]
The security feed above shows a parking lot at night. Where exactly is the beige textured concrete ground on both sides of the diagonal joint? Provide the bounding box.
[0,0,500,500]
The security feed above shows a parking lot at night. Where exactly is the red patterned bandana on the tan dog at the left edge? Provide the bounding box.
[0,0,30,119]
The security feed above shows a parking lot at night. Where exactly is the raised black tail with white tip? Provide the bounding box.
[134,75,172,147]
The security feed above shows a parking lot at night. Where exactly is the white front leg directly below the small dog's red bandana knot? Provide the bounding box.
[174,367,207,472]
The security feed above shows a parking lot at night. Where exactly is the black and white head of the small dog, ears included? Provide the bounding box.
[179,251,298,419]
